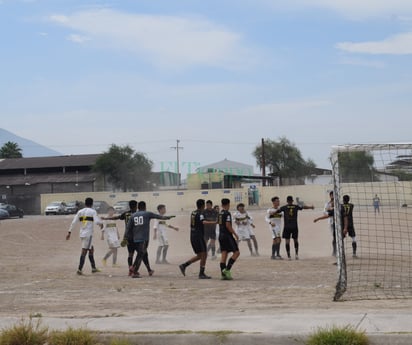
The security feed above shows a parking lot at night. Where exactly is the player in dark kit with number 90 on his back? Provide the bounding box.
[124,201,173,278]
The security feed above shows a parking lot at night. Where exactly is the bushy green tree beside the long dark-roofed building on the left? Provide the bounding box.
[94,144,153,192]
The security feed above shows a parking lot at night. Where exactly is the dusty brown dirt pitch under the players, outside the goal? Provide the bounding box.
[0,210,412,317]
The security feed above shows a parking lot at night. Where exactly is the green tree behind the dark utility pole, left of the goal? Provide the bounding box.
[253,137,316,185]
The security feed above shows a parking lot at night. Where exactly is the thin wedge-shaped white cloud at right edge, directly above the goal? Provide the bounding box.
[336,32,412,55]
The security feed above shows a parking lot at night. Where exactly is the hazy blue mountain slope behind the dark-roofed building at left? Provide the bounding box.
[0,128,62,158]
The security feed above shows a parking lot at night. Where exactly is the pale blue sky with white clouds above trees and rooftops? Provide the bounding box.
[0,0,412,174]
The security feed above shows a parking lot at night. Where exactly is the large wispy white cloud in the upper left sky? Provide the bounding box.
[49,9,254,68]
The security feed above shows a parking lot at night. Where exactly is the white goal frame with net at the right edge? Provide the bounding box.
[331,143,412,301]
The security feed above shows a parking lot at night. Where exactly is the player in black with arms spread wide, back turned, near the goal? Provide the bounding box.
[276,195,314,260]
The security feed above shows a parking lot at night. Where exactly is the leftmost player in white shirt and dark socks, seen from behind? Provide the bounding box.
[66,198,103,275]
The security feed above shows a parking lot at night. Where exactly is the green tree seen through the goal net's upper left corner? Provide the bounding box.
[338,151,379,182]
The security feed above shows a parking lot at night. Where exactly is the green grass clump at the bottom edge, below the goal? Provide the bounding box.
[306,326,369,345]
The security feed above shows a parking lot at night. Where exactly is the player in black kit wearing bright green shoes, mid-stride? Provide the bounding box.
[218,198,240,280]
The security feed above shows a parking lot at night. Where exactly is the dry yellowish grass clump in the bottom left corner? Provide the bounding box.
[0,317,49,345]
